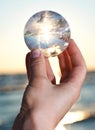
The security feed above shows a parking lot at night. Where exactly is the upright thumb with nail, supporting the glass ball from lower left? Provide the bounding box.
[26,49,47,79]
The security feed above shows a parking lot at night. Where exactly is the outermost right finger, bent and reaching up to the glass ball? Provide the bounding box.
[67,39,86,86]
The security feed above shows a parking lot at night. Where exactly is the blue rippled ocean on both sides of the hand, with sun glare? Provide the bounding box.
[0,72,95,130]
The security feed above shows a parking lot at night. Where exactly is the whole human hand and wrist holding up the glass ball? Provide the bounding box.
[13,40,86,130]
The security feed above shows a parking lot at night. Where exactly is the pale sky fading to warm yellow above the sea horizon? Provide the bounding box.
[0,0,95,74]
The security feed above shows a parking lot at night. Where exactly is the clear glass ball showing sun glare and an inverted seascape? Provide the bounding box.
[24,10,70,57]
